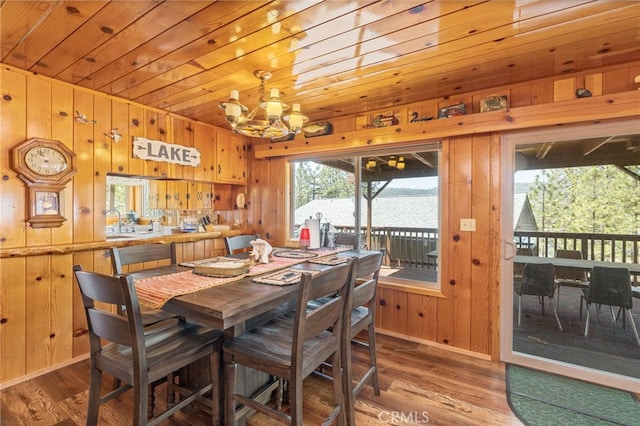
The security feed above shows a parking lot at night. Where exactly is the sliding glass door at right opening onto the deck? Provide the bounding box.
[501,122,640,392]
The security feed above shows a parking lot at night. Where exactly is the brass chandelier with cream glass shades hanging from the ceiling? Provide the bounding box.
[219,70,309,140]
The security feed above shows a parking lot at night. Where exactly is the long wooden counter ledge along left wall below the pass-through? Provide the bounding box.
[0,229,242,259]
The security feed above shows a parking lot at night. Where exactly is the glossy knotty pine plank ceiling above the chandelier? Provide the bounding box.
[0,0,640,127]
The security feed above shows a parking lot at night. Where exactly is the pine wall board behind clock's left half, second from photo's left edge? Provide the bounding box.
[26,77,52,246]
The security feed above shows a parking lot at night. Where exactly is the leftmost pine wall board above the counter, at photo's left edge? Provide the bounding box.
[0,67,27,248]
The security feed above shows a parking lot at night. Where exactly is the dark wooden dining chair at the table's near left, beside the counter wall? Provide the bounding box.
[73,265,223,426]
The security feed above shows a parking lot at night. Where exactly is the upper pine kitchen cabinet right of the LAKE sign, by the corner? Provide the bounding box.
[214,131,247,185]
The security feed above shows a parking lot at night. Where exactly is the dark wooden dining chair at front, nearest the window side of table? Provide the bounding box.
[223,259,357,426]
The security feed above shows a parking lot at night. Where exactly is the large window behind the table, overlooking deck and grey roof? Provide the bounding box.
[291,143,440,288]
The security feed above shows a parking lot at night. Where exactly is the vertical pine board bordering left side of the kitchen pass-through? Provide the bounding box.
[92,96,114,240]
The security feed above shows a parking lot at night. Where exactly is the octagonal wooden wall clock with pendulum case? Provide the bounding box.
[11,138,77,228]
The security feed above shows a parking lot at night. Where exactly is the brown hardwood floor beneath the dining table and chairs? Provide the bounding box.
[0,335,522,426]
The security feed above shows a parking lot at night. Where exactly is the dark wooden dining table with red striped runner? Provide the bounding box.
[130,248,378,424]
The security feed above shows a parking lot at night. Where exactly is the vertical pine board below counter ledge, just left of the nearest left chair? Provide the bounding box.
[50,254,74,365]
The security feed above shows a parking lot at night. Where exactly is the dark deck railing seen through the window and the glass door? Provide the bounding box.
[341,227,640,279]
